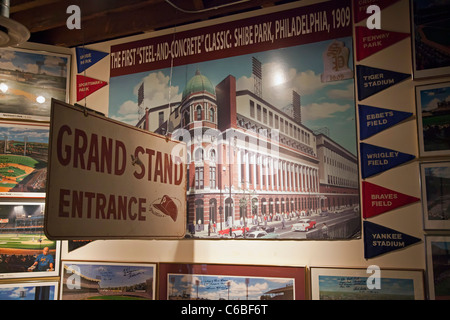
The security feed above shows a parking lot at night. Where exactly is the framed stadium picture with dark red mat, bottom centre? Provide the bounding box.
[159,263,305,300]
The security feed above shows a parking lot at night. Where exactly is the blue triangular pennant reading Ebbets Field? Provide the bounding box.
[358,104,413,140]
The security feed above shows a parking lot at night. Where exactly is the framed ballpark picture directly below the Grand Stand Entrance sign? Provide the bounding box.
[60,261,156,300]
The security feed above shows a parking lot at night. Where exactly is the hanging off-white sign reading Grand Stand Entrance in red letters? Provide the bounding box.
[45,100,186,240]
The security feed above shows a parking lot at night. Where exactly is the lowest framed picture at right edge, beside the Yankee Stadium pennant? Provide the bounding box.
[425,235,450,300]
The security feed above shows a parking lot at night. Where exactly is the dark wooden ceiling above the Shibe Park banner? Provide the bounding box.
[10,0,294,47]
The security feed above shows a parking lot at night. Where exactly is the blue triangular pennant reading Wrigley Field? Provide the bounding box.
[359,142,415,179]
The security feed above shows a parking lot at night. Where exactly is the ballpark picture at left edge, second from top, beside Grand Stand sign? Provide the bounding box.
[0,123,49,196]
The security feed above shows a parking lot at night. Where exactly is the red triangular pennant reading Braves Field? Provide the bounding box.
[362,181,420,219]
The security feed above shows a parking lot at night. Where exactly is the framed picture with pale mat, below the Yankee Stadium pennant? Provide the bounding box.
[310,267,425,300]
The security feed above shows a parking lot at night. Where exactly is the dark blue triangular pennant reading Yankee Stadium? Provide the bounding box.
[363,221,421,259]
